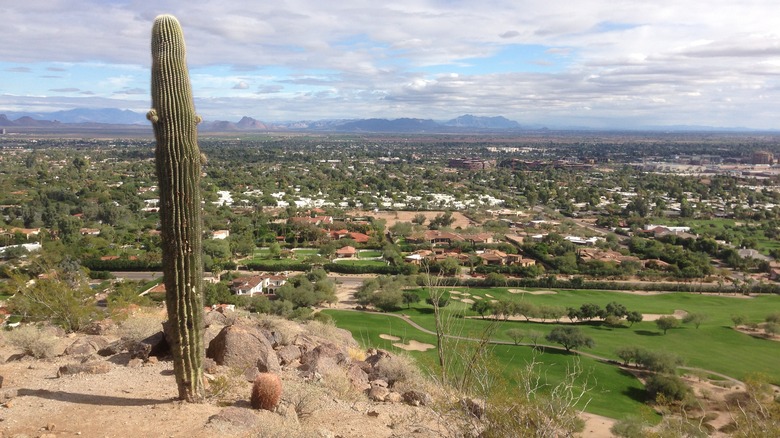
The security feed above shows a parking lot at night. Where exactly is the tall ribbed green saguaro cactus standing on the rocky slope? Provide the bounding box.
[147,15,204,402]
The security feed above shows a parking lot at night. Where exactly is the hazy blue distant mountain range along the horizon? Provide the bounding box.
[0,108,536,133]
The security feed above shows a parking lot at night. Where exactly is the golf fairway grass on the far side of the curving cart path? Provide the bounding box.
[399,288,780,384]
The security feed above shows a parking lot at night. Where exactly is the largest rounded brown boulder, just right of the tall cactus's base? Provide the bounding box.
[206,325,281,372]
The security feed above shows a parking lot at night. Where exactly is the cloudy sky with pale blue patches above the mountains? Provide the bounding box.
[0,0,780,129]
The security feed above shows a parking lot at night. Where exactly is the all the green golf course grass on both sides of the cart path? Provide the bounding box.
[327,288,780,418]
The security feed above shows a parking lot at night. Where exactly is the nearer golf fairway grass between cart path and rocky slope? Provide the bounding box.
[323,310,657,421]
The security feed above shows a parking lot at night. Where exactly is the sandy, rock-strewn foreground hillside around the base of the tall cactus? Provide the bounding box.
[0,312,464,437]
